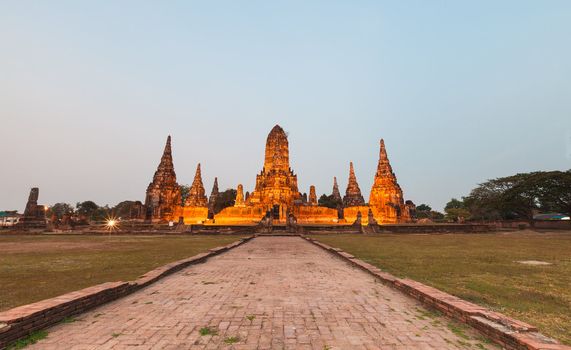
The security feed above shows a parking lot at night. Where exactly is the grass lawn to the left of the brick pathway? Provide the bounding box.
[0,235,241,311]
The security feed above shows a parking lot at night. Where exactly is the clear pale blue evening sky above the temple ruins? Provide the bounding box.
[0,0,571,211]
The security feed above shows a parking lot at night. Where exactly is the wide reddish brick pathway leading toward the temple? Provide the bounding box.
[30,237,496,350]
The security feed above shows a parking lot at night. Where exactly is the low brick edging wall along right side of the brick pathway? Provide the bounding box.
[304,237,571,350]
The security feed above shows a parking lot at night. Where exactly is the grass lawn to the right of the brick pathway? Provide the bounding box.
[313,231,571,345]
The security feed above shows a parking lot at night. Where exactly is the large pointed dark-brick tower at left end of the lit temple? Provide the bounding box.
[145,135,182,221]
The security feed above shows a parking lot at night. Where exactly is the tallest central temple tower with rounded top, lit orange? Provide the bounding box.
[247,125,301,220]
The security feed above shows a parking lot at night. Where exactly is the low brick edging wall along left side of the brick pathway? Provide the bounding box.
[0,236,254,349]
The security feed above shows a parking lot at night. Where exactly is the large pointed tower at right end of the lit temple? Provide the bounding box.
[369,139,410,223]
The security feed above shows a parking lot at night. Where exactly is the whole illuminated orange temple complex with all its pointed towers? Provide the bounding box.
[145,125,410,225]
